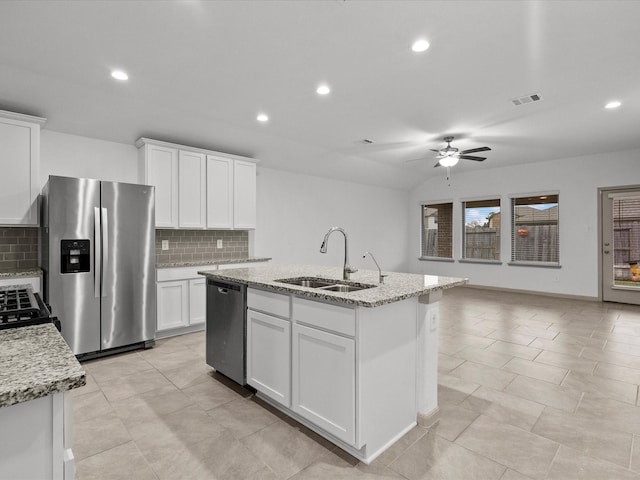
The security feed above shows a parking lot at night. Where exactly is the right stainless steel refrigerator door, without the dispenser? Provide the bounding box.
[101,182,156,350]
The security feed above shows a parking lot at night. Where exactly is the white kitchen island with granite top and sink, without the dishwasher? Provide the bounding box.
[199,265,467,463]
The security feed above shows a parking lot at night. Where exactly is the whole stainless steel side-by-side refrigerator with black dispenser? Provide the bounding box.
[40,176,156,357]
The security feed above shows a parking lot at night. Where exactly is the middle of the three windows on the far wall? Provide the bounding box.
[462,198,500,261]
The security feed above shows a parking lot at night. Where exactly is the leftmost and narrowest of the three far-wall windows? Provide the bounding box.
[421,203,453,258]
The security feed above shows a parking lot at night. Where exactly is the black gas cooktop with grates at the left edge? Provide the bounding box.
[0,285,60,330]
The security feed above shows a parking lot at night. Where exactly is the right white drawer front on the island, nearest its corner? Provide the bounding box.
[293,297,356,337]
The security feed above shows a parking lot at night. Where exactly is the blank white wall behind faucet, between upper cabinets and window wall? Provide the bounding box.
[253,165,409,271]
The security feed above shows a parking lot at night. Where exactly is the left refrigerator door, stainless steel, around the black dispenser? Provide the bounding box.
[43,176,100,355]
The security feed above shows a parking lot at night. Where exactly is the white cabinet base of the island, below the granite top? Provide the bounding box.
[247,288,418,463]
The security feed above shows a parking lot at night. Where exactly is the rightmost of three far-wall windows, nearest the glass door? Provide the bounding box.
[511,195,560,265]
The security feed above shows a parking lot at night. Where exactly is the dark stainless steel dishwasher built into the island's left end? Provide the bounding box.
[207,279,247,385]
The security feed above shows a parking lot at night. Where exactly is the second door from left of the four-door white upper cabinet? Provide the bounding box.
[178,150,207,228]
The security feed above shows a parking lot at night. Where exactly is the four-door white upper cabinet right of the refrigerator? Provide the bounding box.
[136,138,256,230]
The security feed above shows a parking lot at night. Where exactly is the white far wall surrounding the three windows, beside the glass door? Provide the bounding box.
[409,150,640,297]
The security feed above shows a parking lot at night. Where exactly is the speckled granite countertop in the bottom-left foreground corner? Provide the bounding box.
[0,323,86,407]
